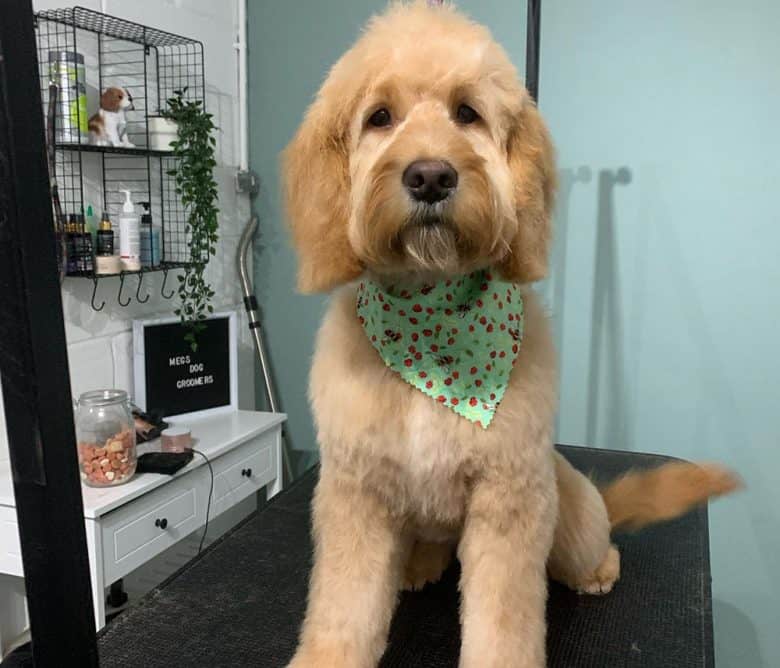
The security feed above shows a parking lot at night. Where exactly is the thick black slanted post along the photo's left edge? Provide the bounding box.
[0,0,98,668]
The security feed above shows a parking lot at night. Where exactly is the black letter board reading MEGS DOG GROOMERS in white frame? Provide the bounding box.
[133,313,238,417]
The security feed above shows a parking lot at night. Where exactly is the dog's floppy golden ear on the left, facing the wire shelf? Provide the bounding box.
[282,89,362,292]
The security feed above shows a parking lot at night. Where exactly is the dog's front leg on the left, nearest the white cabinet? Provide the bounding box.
[289,471,408,668]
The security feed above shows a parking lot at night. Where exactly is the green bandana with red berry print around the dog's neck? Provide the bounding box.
[357,271,523,429]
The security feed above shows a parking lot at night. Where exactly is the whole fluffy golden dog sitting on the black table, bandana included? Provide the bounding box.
[283,2,737,668]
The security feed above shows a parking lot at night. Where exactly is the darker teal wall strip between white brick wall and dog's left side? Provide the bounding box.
[247,0,384,471]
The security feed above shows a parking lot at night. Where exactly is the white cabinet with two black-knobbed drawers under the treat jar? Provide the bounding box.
[0,411,286,648]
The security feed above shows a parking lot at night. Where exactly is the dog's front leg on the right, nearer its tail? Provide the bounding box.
[458,472,556,668]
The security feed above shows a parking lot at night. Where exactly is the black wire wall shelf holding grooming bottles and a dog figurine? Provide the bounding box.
[35,7,205,308]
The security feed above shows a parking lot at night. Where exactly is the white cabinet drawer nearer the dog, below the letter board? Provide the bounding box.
[212,430,279,516]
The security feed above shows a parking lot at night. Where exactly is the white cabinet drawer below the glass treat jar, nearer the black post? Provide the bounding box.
[101,469,208,582]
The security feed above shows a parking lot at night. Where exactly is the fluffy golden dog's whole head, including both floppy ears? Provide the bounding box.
[284,2,555,291]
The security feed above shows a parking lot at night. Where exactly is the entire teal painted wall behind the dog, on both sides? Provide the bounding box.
[249,0,780,668]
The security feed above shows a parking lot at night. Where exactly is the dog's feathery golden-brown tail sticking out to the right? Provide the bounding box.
[599,462,742,530]
